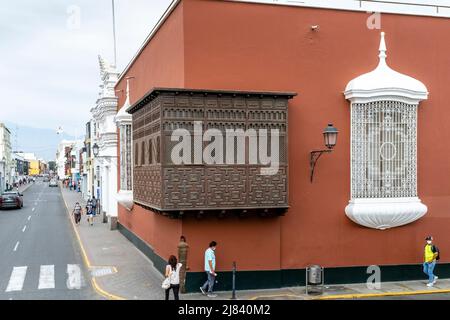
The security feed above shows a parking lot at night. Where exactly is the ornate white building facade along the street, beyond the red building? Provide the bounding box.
[91,57,119,228]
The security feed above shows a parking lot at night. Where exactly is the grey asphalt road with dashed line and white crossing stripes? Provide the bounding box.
[0,180,101,300]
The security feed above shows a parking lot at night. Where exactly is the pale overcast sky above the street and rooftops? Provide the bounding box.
[0,0,171,135]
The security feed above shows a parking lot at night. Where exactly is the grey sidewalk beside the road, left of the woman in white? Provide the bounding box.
[61,187,164,300]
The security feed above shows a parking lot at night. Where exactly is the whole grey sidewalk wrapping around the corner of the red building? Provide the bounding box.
[61,187,450,300]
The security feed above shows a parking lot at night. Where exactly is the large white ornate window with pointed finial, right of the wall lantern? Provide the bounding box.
[345,33,428,230]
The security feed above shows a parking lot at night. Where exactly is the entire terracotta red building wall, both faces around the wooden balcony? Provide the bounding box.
[117,0,450,271]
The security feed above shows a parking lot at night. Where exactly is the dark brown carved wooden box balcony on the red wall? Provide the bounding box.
[128,88,296,217]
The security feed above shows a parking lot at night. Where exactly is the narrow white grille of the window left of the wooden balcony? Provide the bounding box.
[120,125,133,190]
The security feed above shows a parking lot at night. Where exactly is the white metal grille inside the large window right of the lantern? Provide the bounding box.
[351,101,417,198]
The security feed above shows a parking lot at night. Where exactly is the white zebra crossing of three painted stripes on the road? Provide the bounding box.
[5,264,86,292]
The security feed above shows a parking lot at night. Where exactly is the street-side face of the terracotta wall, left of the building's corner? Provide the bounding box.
[116,3,184,259]
